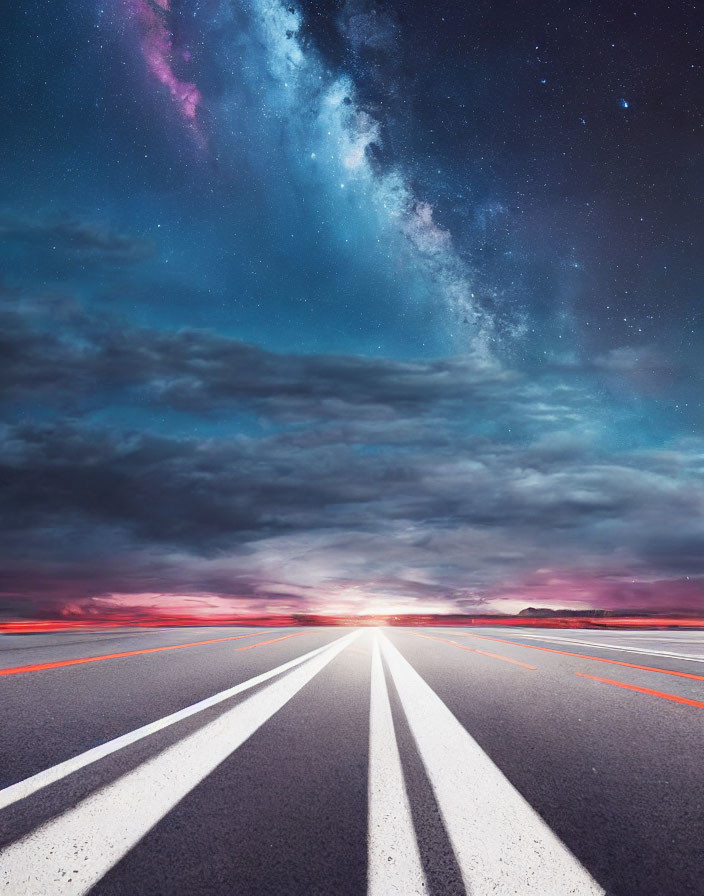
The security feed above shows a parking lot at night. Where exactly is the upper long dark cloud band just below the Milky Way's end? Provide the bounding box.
[0,296,516,420]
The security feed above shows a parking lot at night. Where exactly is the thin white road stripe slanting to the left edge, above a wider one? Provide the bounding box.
[0,632,330,809]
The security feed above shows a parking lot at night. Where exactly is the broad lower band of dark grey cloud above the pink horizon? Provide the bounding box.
[2,402,704,603]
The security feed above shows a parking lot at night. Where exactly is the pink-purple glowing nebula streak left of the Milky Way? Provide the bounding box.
[123,0,202,122]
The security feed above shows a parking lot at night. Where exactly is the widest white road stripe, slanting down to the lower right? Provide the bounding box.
[382,636,604,896]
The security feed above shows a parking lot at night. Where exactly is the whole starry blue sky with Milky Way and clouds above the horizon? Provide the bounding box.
[0,0,704,618]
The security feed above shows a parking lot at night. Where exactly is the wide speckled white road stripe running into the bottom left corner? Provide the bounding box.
[0,631,360,896]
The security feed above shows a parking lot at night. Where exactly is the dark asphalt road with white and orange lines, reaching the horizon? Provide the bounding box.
[0,627,704,896]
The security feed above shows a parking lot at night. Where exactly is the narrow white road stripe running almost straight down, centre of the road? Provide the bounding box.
[367,636,427,896]
